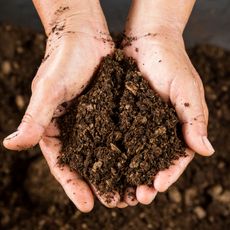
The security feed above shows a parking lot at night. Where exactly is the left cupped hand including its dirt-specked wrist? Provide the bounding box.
[4,1,124,212]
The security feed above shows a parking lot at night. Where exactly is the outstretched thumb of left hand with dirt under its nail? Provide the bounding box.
[3,82,60,150]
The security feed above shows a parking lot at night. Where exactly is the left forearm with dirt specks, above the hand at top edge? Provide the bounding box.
[33,0,107,35]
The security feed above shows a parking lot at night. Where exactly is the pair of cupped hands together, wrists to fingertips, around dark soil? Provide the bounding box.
[4,4,214,212]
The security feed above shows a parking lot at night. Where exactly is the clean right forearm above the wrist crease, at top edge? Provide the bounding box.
[125,0,195,37]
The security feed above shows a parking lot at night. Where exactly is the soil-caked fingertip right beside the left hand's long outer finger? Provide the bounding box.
[91,185,120,208]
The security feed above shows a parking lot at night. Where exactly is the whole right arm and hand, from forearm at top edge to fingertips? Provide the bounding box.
[124,0,214,204]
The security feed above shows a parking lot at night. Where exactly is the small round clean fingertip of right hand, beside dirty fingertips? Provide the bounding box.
[136,185,157,205]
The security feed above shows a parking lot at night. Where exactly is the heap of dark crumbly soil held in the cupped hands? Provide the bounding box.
[58,50,185,196]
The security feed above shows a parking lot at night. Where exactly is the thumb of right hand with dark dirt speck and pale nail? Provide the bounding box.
[170,77,214,156]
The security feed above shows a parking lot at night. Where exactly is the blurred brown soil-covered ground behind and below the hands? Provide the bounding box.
[0,26,230,230]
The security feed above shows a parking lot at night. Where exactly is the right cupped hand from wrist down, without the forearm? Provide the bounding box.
[123,26,214,204]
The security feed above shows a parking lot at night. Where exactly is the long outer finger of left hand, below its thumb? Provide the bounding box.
[39,137,94,212]
